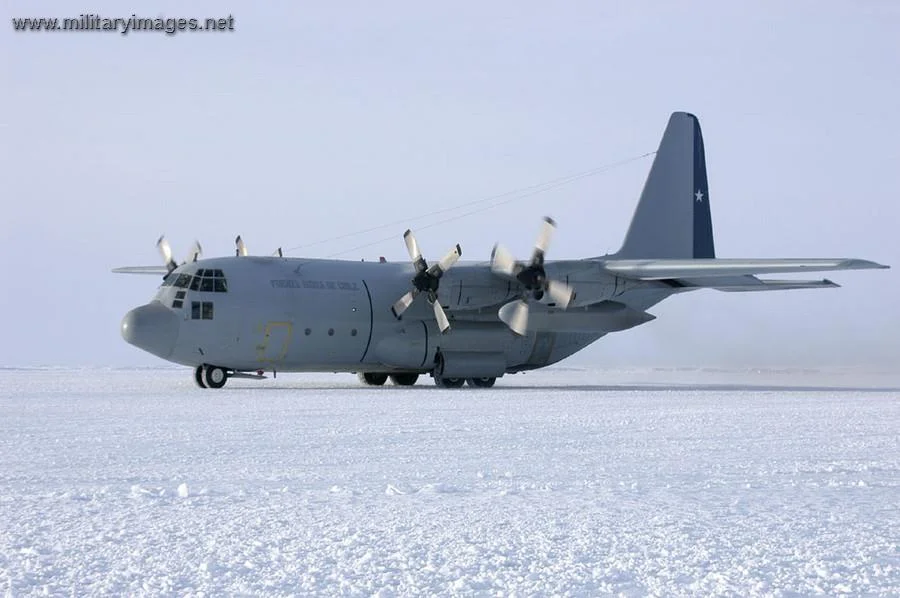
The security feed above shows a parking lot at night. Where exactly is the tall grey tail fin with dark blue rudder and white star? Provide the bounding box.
[616,112,716,259]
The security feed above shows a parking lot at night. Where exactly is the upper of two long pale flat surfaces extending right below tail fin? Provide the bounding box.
[601,258,889,280]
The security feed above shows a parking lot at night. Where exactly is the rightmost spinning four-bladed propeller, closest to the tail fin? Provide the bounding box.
[491,217,575,336]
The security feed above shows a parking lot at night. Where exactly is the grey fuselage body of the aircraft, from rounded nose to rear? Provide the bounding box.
[122,256,652,377]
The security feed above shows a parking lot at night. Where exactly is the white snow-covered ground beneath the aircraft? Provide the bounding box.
[0,368,900,596]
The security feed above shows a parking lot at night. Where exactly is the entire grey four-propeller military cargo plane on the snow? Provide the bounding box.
[113,112,888,388]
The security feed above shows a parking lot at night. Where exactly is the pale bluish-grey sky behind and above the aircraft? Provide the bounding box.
[0,0,900,367]
